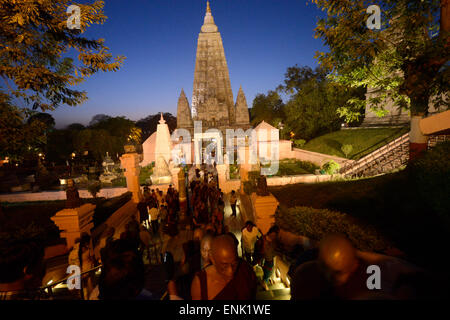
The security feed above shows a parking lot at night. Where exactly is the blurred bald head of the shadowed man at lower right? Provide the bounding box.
[319,235,358,285]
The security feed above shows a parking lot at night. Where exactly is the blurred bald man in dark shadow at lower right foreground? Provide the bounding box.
[291,235,423,300]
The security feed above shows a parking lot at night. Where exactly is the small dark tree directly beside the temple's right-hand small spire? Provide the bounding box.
[250,90,284,127]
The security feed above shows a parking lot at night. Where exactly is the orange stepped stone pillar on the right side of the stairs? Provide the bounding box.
[250,192,279,234]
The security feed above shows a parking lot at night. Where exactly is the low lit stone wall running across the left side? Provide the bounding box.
[0,188,128,202]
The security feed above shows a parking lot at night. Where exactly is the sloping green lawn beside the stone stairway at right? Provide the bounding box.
[302,127,409,160]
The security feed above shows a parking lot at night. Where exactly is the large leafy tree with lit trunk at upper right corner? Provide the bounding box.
[313,0,450,159]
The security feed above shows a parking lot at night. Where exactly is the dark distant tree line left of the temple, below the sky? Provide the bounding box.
[2,112,176,164]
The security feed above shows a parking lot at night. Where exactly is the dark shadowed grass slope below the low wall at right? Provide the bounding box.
[269,170,450,276]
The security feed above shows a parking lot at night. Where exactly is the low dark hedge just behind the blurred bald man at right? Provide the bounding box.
[275,207,391,252]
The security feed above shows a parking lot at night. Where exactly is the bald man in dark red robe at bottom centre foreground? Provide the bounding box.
[191,235,256,300]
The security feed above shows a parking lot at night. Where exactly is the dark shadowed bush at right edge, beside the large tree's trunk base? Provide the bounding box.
[409,141,450,222]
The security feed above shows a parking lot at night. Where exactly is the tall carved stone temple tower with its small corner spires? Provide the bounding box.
[177,2,250,133]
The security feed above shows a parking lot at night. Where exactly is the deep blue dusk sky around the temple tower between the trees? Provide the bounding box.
[52,0,324,128]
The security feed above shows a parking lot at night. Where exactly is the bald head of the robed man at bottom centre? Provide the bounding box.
[211,235,238,280]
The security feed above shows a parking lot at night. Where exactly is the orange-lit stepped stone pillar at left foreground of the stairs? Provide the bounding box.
[51,203,95,249]
